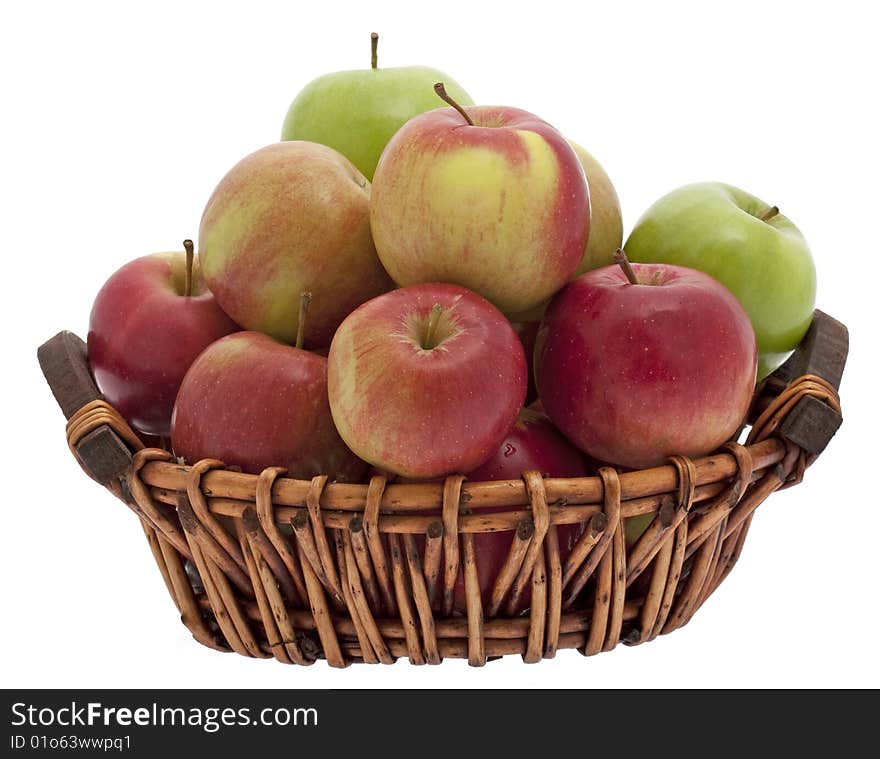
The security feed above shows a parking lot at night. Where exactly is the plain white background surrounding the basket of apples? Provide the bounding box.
[0,0,880,688]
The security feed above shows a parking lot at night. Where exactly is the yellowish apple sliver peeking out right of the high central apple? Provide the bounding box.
[568,140,623,276]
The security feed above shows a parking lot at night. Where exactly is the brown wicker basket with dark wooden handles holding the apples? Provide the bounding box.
[38,311,848,667]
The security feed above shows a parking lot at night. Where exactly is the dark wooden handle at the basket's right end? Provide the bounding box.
[752,309,849,455]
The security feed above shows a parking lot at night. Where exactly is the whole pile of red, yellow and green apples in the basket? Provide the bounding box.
[88,35,816,604]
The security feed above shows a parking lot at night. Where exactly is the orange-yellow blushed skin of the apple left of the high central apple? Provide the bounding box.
[199,141,393,347]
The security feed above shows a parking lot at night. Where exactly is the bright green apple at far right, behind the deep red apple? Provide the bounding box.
[625,182,816,379]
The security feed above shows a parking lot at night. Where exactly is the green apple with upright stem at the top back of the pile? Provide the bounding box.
[281,34,473,181]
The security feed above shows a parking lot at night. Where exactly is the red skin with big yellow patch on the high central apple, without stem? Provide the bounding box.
[370,106,590,315]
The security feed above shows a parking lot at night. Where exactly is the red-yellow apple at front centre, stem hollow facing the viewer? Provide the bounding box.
[328,284,527,479]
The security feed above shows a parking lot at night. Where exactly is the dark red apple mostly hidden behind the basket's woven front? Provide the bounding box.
[455,408,589,611]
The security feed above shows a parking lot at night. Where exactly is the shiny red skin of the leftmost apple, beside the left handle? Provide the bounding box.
[87,251,238,437]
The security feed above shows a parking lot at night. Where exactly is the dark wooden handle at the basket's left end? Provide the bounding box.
[37,330,131,485]
